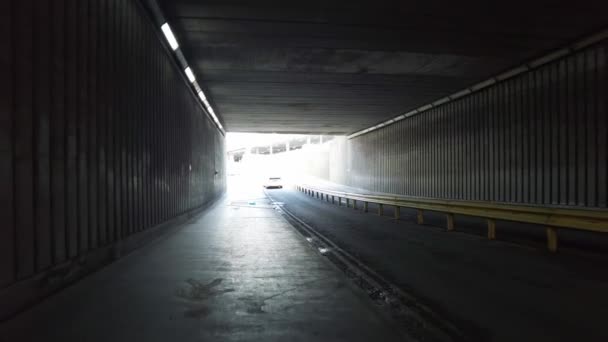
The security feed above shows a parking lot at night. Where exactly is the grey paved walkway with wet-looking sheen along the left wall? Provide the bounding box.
[0,186,406,342]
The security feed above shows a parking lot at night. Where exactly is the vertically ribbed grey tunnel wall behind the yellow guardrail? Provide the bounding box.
[344,41,608,208]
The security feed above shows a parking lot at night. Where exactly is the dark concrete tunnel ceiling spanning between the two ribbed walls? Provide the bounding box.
[159,0,605,134]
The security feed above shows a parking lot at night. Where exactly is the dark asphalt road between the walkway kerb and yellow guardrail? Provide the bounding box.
[267,189,608,341]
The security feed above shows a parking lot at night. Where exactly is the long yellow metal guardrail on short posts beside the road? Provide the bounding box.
[296,185,608,252]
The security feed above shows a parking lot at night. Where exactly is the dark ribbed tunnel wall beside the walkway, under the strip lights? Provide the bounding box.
[0,0,225,308]
